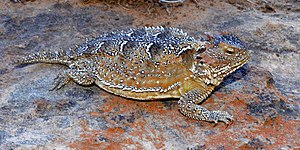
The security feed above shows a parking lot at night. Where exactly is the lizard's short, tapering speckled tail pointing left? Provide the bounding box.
[15,51,71,66]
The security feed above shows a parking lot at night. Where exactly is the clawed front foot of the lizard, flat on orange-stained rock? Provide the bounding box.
[207,111,233,125]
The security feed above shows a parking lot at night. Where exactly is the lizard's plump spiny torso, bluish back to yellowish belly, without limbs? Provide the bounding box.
[76,27,202,100]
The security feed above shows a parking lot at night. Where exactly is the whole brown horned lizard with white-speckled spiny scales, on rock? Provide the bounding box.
[18,27,250,124]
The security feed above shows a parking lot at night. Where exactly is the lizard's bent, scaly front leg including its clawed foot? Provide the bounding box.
[178,88,233,124]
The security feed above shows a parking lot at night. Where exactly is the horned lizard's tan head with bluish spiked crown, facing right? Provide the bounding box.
[192,33,250,86]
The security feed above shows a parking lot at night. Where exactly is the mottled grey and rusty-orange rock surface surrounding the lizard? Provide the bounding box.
[0,0,300,149]
